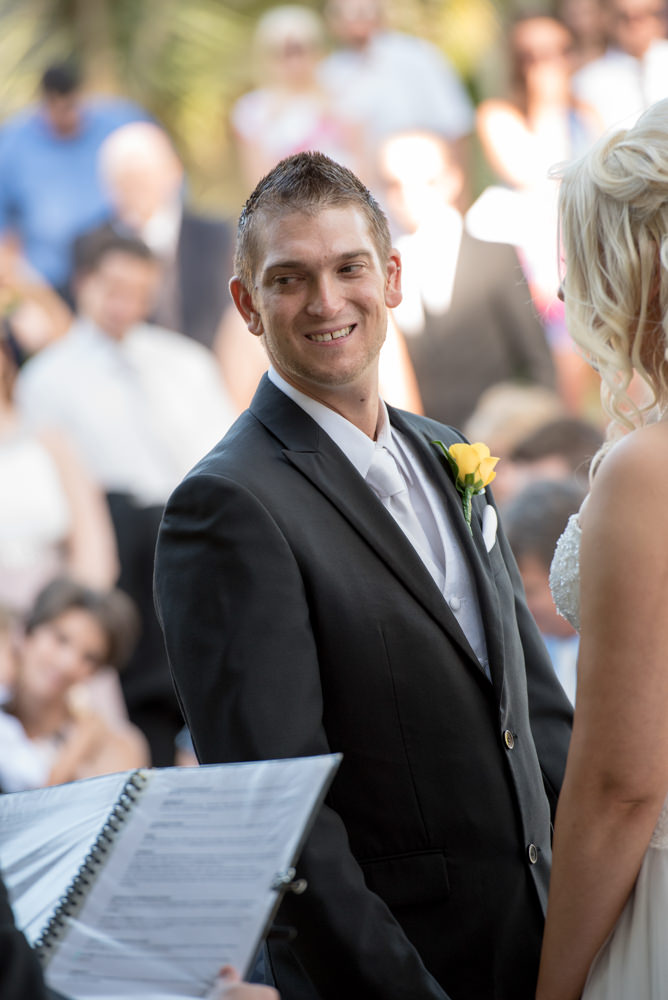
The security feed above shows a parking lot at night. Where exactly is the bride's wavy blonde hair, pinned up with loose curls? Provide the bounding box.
[559,100,668,437]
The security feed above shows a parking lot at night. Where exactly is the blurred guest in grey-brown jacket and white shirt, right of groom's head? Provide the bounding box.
[377,132,555,427]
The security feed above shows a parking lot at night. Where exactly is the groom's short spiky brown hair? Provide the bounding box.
[234,152,392,291]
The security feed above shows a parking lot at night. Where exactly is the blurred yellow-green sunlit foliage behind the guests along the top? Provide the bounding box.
[0,0,546,212]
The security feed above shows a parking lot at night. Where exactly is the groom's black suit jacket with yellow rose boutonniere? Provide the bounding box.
[156,376,571,1000]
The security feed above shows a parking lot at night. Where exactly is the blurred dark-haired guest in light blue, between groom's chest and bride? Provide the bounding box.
[503,480,587,704]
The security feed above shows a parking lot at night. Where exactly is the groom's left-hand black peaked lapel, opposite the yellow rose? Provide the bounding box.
[250,376,480,670]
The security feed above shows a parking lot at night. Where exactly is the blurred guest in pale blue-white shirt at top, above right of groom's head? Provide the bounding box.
[321,0,474,191]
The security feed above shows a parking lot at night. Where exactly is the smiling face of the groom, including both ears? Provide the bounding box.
[232,206,401,408]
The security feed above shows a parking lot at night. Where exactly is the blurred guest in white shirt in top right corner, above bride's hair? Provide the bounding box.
[573,0,668,129]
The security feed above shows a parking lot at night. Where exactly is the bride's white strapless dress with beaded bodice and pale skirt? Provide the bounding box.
[550,514,668,1000]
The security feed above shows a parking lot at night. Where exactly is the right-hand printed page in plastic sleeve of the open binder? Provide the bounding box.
[39,755,340,1000]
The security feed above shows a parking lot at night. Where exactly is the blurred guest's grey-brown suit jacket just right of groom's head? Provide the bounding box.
[406,232,556,427]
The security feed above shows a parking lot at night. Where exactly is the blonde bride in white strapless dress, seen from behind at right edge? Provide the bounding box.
[536,100,668,1000]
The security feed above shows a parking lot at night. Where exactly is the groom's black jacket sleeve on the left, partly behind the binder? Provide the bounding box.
[156,474,446,1000]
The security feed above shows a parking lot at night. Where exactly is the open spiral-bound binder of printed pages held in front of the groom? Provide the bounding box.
[0,754,340,1000]
